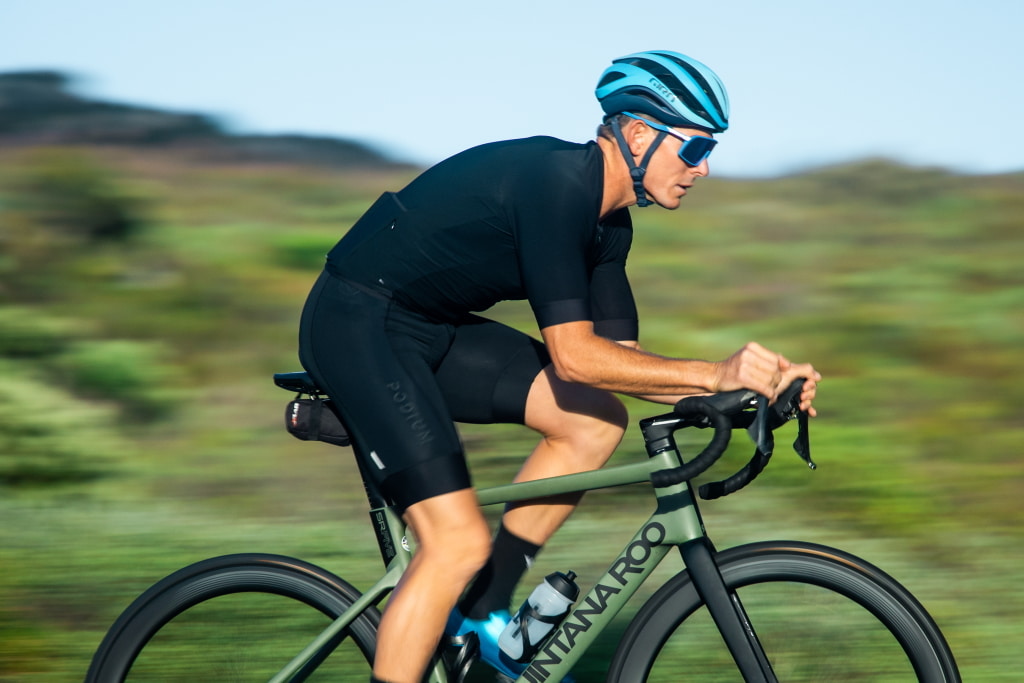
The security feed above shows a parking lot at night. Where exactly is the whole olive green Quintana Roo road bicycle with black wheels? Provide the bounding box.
[86,373,961,683]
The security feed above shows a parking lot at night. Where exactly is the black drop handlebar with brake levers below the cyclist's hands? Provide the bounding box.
[640,379,816,501]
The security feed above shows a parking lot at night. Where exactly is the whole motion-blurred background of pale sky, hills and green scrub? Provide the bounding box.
[0,0,1024,681]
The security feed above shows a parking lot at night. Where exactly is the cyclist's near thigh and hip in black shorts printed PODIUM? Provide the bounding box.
[303,280,469,507]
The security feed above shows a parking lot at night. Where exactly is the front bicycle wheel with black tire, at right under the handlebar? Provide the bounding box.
[607,542,961,683]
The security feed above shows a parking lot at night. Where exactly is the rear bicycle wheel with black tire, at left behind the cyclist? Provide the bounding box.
[85,553,380,683]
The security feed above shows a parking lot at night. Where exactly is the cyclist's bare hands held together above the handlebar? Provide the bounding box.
[715,342,821,417]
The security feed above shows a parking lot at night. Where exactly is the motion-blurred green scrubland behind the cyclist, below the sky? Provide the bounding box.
[0,147,1024,681]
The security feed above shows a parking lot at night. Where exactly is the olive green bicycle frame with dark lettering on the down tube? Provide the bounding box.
[270,447,706,683]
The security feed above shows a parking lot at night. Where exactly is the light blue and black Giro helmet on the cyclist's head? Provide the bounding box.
[595,50,729,133]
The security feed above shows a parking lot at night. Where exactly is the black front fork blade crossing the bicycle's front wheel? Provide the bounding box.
[679,538,778,683]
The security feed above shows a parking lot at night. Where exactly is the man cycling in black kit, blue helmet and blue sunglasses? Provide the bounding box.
[299,51,820,683]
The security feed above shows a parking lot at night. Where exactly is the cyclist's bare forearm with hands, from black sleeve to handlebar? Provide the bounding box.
[541,321,821,415]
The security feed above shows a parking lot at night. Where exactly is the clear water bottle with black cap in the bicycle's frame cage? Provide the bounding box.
[498,571,580,661]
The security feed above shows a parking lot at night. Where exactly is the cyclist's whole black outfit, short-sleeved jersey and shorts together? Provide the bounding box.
[299,137,637,509]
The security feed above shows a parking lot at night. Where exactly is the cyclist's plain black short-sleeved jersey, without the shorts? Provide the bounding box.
[327,137,637,340]
